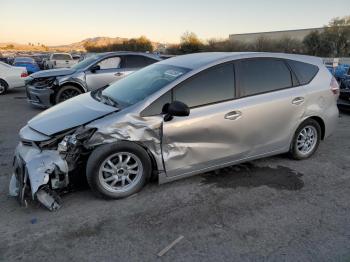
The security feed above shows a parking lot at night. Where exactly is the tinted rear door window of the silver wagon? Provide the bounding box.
[239,58,293,97]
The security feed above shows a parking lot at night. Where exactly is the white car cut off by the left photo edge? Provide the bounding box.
[0,62,28,95]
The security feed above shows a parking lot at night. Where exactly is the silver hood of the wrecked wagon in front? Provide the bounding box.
[28,93,118,136]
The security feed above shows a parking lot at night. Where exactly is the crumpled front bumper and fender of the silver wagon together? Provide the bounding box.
[9,113,170,210]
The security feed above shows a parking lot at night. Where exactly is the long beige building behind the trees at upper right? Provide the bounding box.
[229,27,324,43]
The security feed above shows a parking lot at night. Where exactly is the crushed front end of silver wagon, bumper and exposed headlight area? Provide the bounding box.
[9,126,94,211]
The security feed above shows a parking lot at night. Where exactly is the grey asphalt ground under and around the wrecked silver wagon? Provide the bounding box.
[0,90,350,262]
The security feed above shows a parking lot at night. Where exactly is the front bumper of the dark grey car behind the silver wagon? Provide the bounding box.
[26,85,54,108]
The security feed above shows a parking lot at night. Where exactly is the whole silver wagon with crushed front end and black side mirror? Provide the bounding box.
[10,53,339,210]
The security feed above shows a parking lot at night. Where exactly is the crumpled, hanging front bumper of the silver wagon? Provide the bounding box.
[9,142,69,211]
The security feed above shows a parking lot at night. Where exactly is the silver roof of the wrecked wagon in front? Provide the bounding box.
[160,52,322,69]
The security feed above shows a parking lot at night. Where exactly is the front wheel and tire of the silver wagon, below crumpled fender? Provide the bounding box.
[86,142,152,199]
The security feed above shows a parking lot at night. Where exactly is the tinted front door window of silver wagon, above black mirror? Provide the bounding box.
[173,64,235,107]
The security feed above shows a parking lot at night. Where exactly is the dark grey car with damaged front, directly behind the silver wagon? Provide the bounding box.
[26,52,161,108]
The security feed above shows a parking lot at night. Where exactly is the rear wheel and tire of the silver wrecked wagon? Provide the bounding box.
[289,118,321,160]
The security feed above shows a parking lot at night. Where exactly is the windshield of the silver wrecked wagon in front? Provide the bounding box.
[102,64,190,106]
